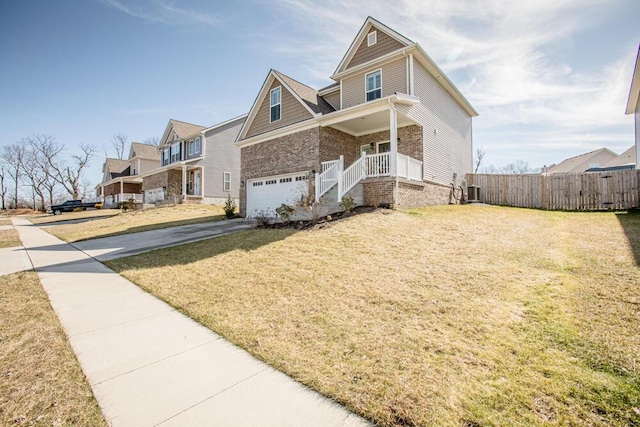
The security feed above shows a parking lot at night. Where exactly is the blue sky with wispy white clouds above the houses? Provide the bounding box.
[0,0,640,191]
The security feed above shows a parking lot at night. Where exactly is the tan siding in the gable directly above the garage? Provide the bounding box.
[246,79,313,138]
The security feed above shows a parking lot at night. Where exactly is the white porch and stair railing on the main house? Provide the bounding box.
[316,153,422,201]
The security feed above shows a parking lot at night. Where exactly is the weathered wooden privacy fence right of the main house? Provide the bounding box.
[467,170,640,211]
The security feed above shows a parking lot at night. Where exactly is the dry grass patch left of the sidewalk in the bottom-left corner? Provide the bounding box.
[0,272,106,426]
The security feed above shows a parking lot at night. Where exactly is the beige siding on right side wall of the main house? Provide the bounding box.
[397,61,473,185]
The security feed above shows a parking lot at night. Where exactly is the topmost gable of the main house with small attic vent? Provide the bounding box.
[334,17,415,75]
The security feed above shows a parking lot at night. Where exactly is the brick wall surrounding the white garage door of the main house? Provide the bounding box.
[240,128,320,216]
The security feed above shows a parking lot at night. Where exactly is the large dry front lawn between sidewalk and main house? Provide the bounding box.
[108,206,640,426]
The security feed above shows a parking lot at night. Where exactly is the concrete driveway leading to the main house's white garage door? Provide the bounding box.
[67,218,255,261]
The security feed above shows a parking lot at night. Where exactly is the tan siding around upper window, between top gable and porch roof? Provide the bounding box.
[342,58,407,108]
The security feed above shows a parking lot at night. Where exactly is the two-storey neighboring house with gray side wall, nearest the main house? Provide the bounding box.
[142,115,246,204]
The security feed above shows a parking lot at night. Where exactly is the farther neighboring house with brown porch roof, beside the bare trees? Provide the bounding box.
[96,142,160,207]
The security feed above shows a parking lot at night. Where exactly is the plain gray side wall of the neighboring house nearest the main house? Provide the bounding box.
[202,118,244,202]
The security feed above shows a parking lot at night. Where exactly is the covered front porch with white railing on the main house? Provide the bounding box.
[315,94,423,201]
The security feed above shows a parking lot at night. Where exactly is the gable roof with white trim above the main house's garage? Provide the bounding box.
[238,69,335,140]
